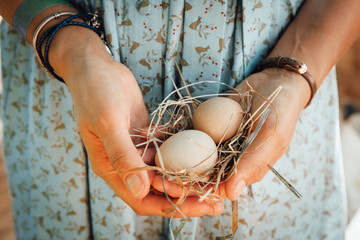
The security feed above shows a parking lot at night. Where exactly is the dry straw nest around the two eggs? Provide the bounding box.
[134,74,281,202]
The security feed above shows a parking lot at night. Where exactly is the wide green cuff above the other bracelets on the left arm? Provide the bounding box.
[13,0,74,39]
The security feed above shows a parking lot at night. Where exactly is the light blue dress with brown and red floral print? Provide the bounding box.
[0,0,346,239]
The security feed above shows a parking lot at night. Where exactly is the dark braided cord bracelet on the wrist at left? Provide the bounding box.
[36,14,112,83]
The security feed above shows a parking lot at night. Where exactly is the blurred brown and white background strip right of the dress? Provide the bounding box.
[336,38,360,240]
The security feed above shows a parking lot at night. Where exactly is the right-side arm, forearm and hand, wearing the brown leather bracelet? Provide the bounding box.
[226,0,360,200]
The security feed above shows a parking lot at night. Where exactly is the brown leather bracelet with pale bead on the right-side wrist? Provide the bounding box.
[256,56,317,108]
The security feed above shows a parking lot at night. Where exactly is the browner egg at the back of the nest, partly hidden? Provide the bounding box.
[193,97,243,143]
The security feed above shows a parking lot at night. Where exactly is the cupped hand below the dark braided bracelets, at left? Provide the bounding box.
[49,26,222,217]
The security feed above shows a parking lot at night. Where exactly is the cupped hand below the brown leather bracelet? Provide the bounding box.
[226,68,310,200]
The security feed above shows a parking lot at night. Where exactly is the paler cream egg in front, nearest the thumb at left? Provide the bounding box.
[155,130,217,176]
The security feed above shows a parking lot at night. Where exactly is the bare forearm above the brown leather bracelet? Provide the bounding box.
[269,0,360,87]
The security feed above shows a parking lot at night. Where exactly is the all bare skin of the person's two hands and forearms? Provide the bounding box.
[0,0,360,217]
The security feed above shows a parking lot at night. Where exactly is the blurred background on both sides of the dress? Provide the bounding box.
[0,17,360,240]
